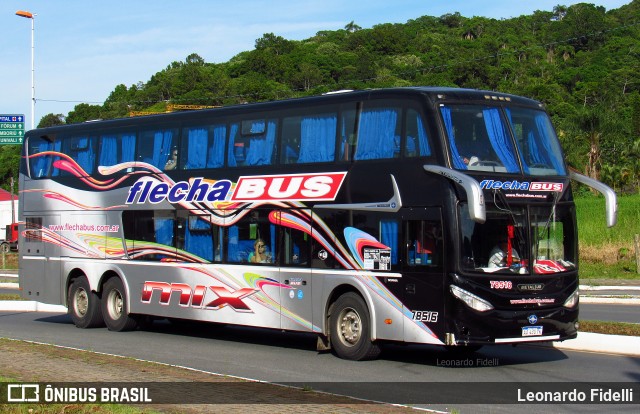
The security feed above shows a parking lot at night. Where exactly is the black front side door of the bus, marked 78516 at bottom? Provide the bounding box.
[398,207,445,342]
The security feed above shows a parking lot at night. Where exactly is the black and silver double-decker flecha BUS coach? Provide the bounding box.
[19,87,616,360]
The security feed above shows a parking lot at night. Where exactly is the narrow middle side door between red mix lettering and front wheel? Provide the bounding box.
[277,210,313,332]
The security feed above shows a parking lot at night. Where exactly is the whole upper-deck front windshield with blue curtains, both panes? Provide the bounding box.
[440,105,566,176]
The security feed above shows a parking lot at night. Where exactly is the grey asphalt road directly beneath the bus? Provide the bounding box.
[0,312,640,413]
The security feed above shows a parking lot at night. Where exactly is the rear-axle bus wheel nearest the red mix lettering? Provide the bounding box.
[102,277,138,332]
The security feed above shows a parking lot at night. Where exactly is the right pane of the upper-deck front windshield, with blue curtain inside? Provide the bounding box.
[506,107,566,175]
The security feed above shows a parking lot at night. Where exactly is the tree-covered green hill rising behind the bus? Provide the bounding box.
[28,0,640,192]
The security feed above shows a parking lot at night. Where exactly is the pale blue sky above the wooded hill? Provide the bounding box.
[0,0,631,130]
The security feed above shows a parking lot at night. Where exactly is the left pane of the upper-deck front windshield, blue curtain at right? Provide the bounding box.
[440,105,520,173]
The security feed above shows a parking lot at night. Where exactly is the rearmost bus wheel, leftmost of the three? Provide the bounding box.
[67,275,104,329]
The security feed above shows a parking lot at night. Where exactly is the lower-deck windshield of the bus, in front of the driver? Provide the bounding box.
[459,205,576,274]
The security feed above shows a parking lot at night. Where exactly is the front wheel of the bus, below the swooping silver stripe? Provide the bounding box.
[329,292,380,361]
